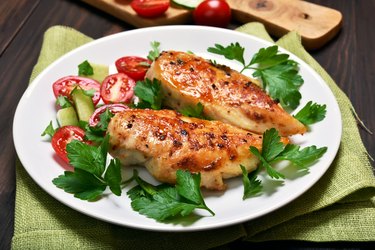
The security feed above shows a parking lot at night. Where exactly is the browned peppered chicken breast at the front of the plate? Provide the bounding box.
[107,109,288,190]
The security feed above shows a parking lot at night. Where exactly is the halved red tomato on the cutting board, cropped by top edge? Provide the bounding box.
[130,0,169,18]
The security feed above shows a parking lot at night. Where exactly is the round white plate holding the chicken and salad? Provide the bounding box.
[13,26,341,231]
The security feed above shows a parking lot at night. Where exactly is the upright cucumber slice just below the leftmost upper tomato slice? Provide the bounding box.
[71,88,95,122]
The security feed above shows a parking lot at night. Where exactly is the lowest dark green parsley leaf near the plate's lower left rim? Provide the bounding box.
[52,169,107,200]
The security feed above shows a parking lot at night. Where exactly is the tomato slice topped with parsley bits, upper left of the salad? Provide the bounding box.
[52,76,100,105]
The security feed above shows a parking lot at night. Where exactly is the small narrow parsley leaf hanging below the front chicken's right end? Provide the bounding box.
[240,165,263,200]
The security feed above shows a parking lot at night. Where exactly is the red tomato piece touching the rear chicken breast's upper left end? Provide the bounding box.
[115,56,152,81]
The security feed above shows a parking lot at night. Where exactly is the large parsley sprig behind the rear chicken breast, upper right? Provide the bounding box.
[207,42,303,110]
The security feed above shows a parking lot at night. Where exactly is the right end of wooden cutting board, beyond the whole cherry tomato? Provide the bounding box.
[228,0,342,49]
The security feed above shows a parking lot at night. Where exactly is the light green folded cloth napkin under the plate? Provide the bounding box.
[12,23,375,249]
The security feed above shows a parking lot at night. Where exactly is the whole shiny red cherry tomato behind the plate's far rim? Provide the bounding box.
[193,0,231,27]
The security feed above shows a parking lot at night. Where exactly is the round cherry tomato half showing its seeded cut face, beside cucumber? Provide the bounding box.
[100,73,135,104]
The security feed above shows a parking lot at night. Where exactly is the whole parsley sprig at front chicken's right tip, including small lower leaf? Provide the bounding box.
[241,128,327,199]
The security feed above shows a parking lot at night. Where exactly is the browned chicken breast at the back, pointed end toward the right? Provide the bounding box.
[146,51,306,136]
